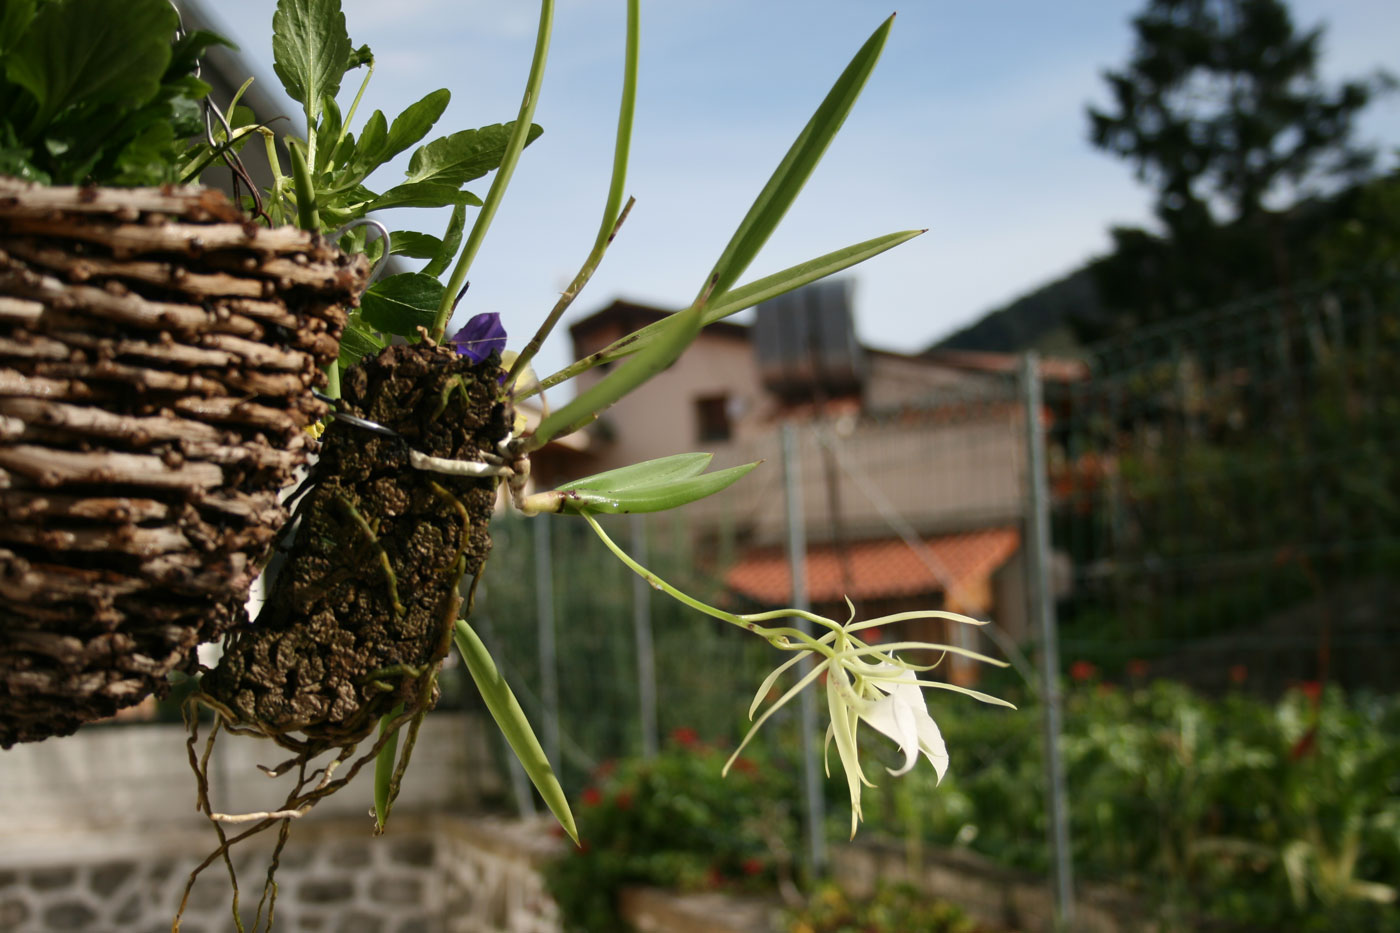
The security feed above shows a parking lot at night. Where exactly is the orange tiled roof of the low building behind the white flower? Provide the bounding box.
[724,528,1021,605]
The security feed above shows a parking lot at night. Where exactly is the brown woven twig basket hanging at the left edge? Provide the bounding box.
[0,178,368,747]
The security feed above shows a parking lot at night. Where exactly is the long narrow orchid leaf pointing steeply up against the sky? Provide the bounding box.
[700,15,895,296]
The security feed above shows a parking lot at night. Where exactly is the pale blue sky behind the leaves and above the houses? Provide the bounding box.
[206,0,1400,383]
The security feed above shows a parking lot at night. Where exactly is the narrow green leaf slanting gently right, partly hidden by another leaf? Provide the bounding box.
[540,230,924,389]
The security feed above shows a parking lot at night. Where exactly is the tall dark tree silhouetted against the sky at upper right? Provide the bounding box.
[1088,0,1393,235]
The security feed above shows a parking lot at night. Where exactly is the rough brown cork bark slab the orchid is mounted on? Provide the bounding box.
[203,343,512,754]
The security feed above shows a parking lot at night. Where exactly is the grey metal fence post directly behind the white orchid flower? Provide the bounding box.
[783,422,826,876]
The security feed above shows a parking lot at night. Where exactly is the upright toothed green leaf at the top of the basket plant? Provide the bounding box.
[272,0,354,124]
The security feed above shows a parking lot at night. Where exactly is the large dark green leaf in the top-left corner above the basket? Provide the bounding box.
[4,0,179,129]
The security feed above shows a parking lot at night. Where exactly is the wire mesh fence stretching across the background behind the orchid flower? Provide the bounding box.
[448,270,1400,925]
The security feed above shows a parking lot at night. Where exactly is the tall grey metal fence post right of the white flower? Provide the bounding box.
[1021,353,1074,930]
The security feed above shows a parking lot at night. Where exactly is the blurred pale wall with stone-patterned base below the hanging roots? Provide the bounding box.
[0,713,559,933]
